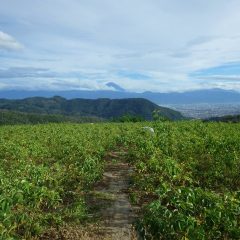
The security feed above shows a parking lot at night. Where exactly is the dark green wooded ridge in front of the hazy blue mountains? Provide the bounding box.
[0,97,184,120]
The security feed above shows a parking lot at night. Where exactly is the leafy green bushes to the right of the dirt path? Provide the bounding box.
[123,121,240,239]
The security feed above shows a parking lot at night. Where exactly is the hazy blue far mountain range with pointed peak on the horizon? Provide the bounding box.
[0,87,240,105]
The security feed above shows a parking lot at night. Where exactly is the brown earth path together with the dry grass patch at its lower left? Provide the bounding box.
[41,151,139,240]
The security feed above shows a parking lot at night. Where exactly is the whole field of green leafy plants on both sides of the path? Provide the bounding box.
[0,121,240,239]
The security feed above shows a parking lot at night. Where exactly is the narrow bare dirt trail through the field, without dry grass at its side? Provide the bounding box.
[86,151,137,240]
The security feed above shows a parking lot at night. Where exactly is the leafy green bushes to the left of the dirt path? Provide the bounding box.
[0,124,118,239]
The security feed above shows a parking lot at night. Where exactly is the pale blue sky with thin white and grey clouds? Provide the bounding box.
[0,0,240,92]
